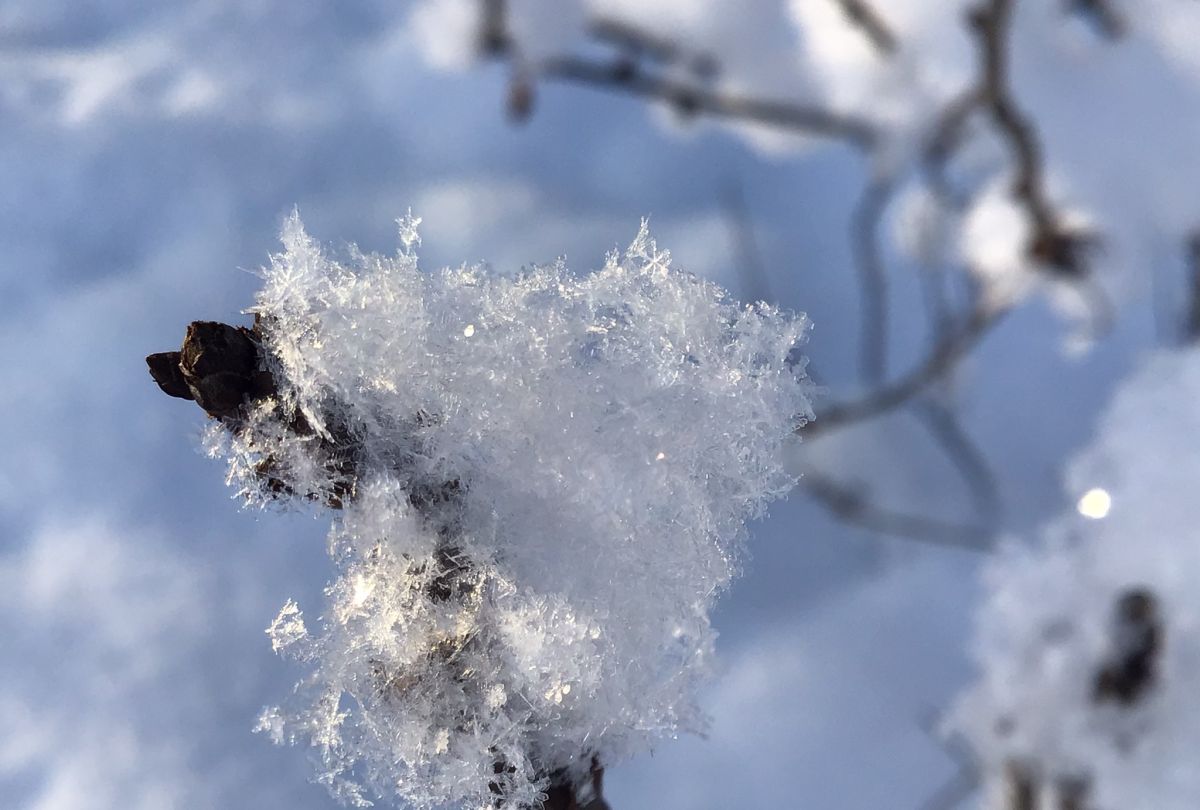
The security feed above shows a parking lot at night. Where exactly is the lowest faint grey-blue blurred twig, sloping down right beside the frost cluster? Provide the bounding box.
[800,470,992,551]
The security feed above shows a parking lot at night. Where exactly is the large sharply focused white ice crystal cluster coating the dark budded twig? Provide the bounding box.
[214,216,809,808]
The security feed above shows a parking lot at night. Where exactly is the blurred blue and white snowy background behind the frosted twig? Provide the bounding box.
[0,0,1200,810]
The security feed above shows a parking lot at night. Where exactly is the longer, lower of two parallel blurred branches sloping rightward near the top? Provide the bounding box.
[538,55,877,150]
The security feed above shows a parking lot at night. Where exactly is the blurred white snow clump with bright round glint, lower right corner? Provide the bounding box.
[952,349,1200,810]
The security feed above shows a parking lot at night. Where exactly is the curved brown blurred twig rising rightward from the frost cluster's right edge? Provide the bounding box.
[797,302,1007,437]
